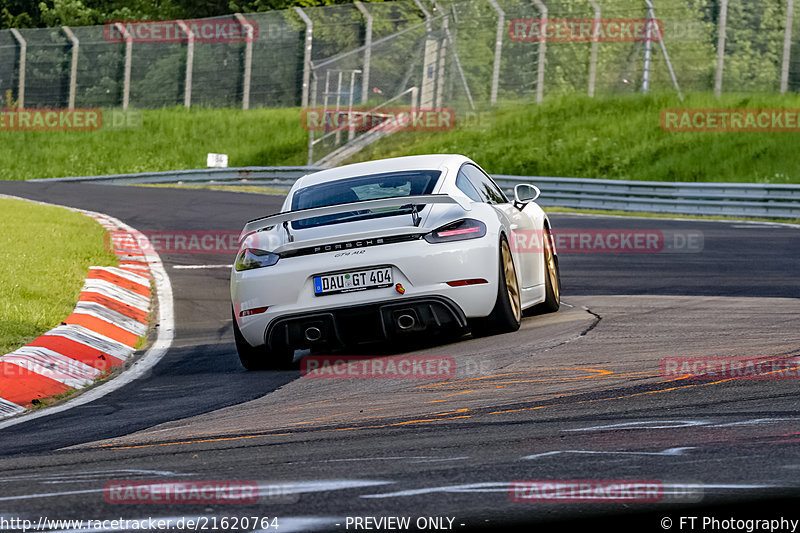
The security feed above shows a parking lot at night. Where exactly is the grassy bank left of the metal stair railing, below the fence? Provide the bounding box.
[0,107,308,180]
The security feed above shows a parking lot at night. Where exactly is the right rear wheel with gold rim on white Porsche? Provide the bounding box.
[470,237,522,337]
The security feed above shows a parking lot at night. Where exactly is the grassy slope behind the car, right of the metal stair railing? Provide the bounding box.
[353,94,800,183]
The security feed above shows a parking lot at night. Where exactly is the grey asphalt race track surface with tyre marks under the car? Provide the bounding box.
[0,182,800,532]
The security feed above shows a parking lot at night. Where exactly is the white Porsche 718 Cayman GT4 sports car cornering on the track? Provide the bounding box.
[231,155,559,369]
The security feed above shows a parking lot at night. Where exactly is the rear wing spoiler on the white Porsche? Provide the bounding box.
[239,194,472,241]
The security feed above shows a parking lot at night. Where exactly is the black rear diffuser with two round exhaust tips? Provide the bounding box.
[264,296,467,350]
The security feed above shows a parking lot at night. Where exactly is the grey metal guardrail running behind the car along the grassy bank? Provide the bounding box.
[29,166,800,219]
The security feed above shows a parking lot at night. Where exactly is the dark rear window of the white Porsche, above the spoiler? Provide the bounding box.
[292,170,442,228]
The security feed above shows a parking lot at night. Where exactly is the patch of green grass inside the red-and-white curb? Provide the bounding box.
[0,198,118,355]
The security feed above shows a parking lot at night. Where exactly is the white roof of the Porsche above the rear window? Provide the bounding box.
[293,154,472,189]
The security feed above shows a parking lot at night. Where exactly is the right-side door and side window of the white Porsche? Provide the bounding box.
[459,163,543,288]
